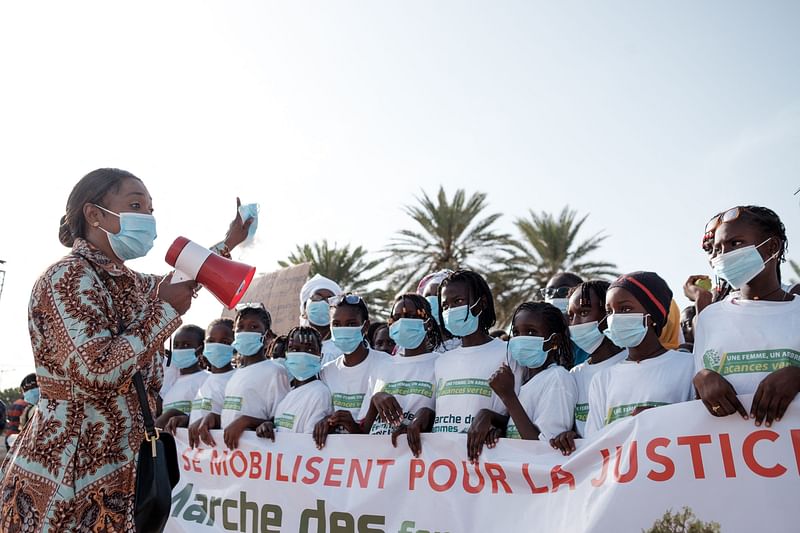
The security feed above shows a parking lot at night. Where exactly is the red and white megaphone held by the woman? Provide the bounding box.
[165,237,256,309]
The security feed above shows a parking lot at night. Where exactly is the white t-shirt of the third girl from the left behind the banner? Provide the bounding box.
[221,359,289,429]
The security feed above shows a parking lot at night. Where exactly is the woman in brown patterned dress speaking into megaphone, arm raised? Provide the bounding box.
[0,169,252,532]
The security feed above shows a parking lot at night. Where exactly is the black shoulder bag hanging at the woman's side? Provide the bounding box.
[133,372,180,533]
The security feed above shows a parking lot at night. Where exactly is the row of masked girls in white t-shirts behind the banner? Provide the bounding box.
[153,206,800,461]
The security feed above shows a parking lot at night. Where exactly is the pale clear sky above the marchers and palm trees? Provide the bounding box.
[0,1,800,387]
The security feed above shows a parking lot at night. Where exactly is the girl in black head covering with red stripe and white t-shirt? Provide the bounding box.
[586,272,694,436]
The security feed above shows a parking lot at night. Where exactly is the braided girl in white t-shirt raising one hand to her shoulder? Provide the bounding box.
[487,302,577,447]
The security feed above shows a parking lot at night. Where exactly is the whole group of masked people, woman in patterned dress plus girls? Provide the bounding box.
[0,169,800,532]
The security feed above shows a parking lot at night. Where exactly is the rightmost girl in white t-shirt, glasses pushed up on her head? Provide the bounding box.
[694,206,800,426]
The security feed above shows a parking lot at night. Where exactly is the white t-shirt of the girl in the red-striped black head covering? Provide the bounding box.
[586,350,695,436]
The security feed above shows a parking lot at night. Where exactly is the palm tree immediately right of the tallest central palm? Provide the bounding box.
[510,206,617,296]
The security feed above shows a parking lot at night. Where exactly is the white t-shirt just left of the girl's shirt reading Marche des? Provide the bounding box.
[358,352,439,435]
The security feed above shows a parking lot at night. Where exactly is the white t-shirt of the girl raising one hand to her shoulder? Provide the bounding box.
[506,363,578,442]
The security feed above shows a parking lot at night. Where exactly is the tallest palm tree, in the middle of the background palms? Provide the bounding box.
[386,186,508,292]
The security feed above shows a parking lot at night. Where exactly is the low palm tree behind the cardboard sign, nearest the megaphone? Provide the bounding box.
[278,239,384,295]
